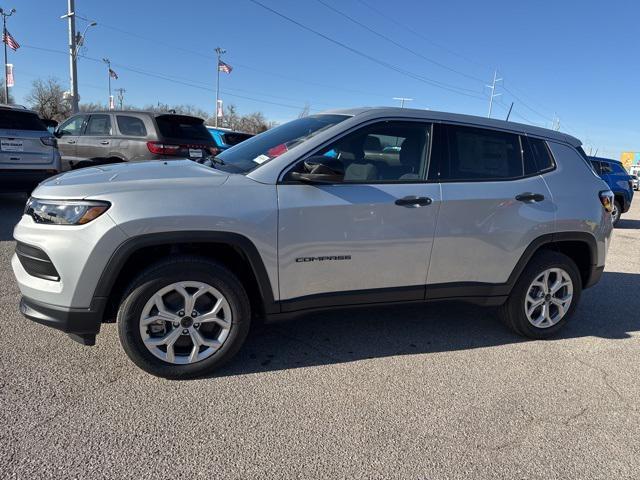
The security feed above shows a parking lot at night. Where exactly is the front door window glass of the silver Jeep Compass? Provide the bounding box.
[302,121,431,183]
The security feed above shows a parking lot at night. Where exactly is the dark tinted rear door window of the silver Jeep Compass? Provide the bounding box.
[440,126,524,181]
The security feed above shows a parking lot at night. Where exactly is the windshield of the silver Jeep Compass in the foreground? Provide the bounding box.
[216,115,349,173]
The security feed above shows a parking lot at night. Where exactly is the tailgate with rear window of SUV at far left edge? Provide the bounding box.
[0,109,54,168]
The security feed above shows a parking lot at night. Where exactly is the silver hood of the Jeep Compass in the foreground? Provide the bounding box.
[32,160,229,199]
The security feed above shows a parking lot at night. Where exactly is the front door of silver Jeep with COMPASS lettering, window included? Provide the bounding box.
[278,121,440,311]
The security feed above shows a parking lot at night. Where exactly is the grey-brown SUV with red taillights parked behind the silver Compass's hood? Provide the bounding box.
[55,110,217,170]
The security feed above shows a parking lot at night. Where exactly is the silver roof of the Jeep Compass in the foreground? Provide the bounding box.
[322,107,582,147]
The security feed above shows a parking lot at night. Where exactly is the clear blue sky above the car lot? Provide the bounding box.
[6,0,640,158]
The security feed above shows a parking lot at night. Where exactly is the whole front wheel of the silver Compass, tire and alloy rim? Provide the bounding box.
[118,257,250,379]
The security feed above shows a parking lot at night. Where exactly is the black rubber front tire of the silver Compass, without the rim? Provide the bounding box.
[117,256,251,380]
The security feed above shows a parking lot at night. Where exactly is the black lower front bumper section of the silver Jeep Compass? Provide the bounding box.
[20,297,107,345]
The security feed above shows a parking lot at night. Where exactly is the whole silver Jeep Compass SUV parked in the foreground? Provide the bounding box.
[12,108,613,378]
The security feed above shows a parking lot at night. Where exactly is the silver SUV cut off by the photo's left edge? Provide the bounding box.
[0,105,62,192]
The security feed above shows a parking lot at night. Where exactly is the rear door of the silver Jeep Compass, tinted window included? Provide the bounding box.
[427,125,555,292]
